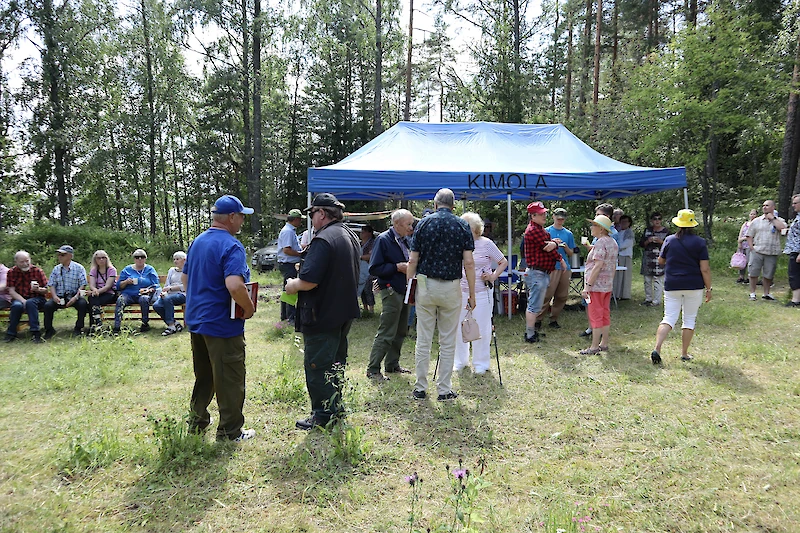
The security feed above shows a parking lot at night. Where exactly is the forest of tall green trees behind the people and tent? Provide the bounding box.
[0,0,800,251]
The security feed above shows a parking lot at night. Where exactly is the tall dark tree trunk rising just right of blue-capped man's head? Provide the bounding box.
[247,0,264,247]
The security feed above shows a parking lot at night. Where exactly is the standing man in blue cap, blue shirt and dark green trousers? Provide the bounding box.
[181,194,256,442]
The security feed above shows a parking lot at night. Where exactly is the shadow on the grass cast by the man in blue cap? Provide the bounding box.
[122,432,237,531]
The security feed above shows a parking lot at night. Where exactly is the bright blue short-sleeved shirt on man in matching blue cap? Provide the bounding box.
[183,228,250,339]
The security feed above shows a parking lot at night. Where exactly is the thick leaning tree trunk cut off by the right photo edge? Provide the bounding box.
[778,24,800,217]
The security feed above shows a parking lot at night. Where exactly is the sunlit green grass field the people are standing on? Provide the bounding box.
[0,243,800,533]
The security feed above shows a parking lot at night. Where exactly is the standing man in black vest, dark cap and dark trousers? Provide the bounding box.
[286,193,361,430]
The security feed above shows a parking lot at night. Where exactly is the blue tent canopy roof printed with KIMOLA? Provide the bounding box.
[308,122,686,200]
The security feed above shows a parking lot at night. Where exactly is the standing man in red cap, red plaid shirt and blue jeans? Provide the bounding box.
[523,202,567,342]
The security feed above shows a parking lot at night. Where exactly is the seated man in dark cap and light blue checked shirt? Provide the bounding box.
[44,244,89,340]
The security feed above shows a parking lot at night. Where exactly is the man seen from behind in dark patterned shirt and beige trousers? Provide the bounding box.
[406,189,475,401]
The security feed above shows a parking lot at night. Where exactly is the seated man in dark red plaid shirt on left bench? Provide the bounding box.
[4,250,47,344]
